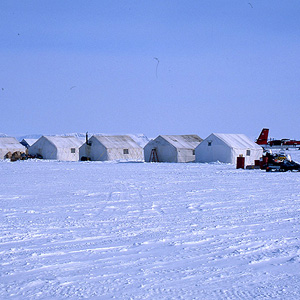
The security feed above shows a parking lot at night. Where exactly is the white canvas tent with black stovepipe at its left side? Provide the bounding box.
[79,135,144,161]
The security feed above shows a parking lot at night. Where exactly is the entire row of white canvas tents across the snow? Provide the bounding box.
[0,133,263,165]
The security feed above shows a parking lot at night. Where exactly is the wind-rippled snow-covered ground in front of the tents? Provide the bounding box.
[0,151,300,299]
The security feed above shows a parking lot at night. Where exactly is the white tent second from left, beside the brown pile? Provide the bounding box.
[28,136,82,161]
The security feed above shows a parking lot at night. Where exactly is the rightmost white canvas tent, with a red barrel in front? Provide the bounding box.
[196,133,263,165]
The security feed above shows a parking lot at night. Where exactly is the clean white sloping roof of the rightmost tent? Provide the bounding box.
[212,133,262,149]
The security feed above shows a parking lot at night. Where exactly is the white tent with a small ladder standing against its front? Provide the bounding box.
[144,134,202,162]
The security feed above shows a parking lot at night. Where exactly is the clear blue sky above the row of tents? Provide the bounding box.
[0,0,300,139]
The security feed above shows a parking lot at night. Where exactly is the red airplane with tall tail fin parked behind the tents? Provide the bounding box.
[256,128,300,150]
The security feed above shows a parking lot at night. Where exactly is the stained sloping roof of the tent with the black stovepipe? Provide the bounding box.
[93,135,141,149]
